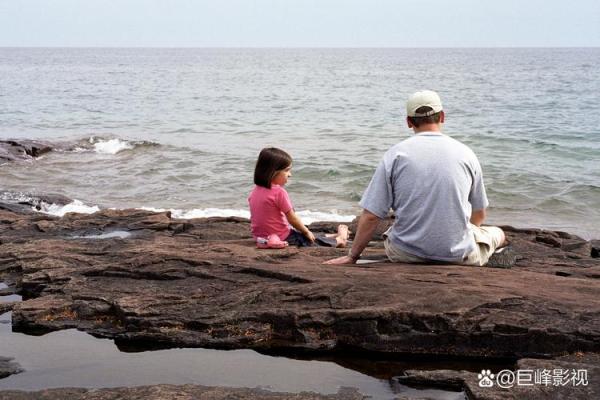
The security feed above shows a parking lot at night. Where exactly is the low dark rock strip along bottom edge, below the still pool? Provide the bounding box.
[0,385,367,400]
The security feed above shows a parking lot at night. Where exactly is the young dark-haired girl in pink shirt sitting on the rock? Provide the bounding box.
[248,147,348,247]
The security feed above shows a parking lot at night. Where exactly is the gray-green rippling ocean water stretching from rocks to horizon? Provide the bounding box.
[0,48,600,239]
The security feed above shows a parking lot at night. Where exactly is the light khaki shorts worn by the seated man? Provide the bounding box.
[383,224,504,266]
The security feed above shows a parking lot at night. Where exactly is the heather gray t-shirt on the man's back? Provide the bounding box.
[360,132,488,262]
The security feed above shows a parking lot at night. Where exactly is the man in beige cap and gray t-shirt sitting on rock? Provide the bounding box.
[326,90,505,266]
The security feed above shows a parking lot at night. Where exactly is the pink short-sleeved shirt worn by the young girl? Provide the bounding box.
[248,185,293,240]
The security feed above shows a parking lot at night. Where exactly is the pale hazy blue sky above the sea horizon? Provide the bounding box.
[0,0,600,47]
